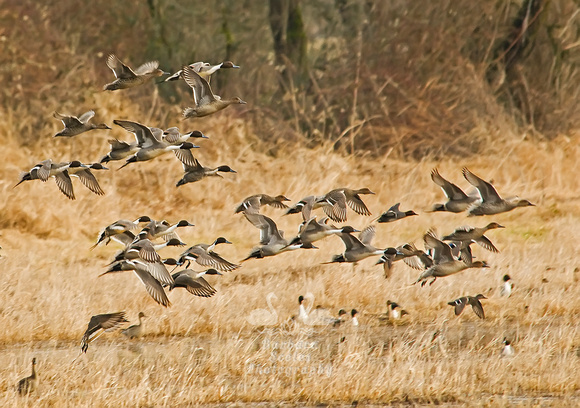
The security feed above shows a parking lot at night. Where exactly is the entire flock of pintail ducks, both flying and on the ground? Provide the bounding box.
[15,54,533,394]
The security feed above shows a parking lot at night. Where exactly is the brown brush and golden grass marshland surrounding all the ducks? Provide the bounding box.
[0,0,580,407]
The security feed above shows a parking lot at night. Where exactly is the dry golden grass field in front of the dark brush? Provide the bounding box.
[0,103,580,407]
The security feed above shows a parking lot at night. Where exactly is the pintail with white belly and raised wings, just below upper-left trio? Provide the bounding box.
[113,120,199,169]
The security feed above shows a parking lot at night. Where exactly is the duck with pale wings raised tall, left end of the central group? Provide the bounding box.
[242,213,301,262]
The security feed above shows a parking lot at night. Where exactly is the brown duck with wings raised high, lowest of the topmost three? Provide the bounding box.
[183,66,246,119]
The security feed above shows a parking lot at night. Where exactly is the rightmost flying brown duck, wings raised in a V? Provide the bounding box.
[463,167,534,217]
